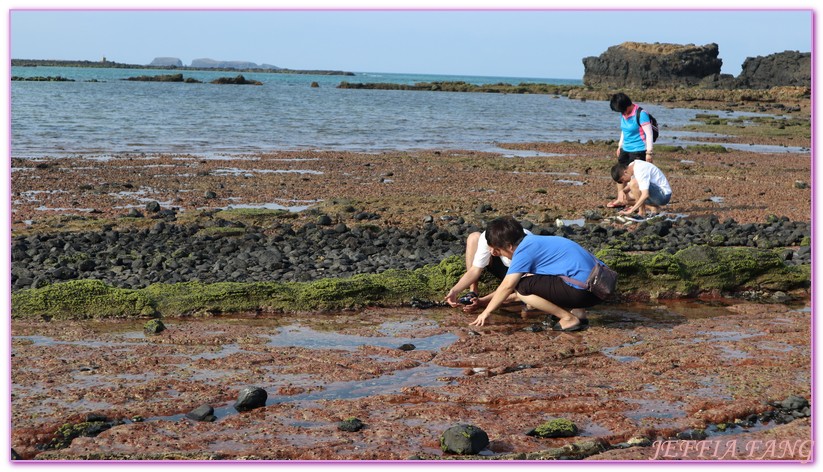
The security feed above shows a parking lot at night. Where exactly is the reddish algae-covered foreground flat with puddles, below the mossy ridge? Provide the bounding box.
[11,300,811,460]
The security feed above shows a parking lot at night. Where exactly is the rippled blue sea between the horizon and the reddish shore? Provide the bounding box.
[11,67,792,157]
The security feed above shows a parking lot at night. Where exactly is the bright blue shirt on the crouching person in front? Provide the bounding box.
[507,234,595,288]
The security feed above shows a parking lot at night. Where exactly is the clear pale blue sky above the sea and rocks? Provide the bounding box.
[10,8,812,79]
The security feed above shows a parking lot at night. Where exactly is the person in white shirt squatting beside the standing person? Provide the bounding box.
[612,160,672,216]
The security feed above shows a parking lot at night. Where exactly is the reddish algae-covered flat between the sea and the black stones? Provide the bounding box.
[11,143,811,231]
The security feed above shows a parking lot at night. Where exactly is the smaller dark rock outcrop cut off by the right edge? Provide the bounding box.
[737,51,812,89]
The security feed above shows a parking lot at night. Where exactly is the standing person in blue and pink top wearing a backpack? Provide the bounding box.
[606,92,654,208]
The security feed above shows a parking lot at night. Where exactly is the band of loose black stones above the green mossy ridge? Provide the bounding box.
[11,212,811,296]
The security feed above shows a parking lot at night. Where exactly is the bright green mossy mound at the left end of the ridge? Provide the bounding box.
[11,280,157,319]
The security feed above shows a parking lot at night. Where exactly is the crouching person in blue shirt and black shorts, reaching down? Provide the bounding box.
[470,217,601,331]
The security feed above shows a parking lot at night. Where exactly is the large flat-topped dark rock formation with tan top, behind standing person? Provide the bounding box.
[583,42,723,87]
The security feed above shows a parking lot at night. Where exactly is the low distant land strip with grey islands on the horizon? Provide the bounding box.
[11,58,354,76]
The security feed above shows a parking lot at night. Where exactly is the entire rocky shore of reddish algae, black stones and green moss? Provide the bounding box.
[11,82,812,461]
